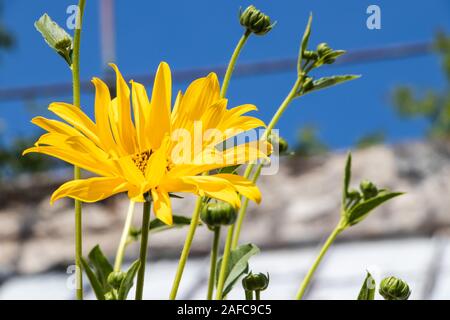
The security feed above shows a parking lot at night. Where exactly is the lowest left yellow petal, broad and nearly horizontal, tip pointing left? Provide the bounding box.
[50,177,127,203]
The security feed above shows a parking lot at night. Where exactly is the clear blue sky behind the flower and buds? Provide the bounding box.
[0,0,450,148]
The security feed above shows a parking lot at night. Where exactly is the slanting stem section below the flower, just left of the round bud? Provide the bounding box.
[169,197,203,300]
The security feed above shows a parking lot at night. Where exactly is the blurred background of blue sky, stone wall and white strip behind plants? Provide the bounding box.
[0,0,450,299]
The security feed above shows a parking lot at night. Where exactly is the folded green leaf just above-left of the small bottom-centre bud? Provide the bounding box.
[216,243,259,296]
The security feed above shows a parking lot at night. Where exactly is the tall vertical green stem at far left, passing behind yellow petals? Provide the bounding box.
[71,0,86,300]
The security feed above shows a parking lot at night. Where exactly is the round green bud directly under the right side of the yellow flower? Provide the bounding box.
[200,201,237,228]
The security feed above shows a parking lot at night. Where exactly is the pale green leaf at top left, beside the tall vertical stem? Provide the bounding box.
[34,13,72,66]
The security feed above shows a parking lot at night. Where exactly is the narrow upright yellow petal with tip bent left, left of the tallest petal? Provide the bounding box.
[110,64,137,154]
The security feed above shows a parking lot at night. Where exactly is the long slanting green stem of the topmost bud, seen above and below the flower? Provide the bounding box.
[169,31,251,300]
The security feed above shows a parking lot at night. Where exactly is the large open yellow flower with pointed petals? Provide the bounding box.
[24,62,271,224]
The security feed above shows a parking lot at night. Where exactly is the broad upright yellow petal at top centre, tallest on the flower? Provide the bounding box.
[146,62,172,150]
